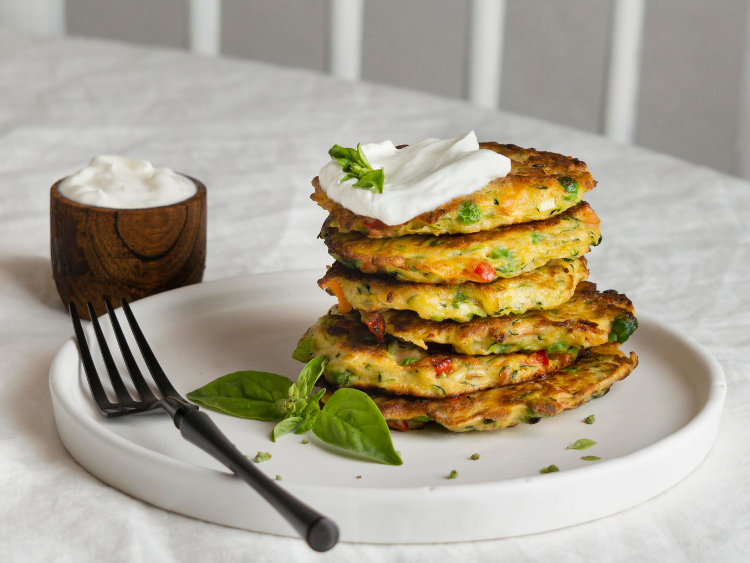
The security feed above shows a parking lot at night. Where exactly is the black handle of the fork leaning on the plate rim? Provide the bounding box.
[175,410,339,551]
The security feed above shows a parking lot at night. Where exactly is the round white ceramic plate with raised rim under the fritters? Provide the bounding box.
[50,271,726,543]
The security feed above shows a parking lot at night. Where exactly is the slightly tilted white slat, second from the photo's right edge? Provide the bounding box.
[604,0,646,143]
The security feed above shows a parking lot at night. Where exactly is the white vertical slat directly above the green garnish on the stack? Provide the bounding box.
[329,0,365,81]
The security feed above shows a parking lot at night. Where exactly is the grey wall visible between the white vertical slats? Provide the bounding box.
[66,0,748,178]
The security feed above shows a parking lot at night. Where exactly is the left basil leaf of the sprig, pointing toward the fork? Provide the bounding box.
[187,371,292,420]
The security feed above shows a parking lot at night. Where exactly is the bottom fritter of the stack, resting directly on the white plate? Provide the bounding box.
[323,344,638,432]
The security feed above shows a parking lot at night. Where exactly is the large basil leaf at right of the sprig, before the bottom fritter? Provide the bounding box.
[313,389,403,465]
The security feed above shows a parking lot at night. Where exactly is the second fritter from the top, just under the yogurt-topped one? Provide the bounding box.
[321,201,602,284]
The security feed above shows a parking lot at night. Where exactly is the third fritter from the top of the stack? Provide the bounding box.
[318,256,589,322]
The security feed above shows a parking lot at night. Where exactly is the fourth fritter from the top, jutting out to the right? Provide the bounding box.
[362,282,638,355]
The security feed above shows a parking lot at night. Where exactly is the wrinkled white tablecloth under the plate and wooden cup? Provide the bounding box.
[0,33,750,563]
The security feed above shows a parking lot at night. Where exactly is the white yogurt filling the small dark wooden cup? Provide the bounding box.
[59,155,198,209]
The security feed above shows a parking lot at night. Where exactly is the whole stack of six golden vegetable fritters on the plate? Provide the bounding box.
[295,143,637,431]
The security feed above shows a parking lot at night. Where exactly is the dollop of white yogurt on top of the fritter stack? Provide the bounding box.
[319,131,511,225]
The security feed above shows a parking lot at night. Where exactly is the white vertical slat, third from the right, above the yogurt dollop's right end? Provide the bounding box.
[467,0,505,109]
